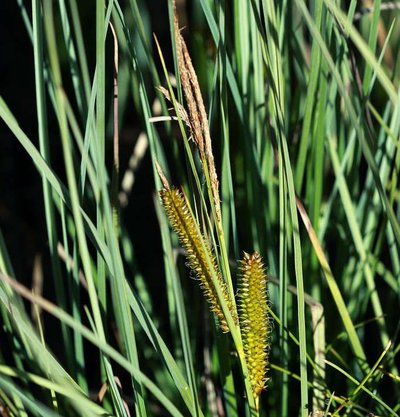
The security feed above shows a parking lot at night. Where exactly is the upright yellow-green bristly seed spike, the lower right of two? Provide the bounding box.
[238,252,270,404]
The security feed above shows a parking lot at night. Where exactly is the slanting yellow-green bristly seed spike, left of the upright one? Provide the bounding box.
[160,188,238,333]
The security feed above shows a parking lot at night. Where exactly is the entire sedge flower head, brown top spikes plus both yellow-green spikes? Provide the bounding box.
[156,1,269,402]
